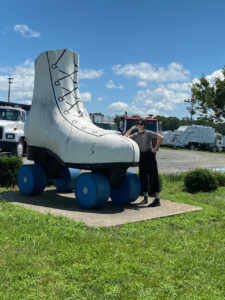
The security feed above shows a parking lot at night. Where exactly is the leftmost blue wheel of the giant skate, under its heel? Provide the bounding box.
[17,165,47,196]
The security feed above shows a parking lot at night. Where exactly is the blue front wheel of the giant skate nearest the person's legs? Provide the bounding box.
[110,170,141,204]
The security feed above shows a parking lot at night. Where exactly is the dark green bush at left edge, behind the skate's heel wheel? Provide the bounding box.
[0,155,23,187]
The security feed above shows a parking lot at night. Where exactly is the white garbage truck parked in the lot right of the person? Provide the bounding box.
[166,125,222,152]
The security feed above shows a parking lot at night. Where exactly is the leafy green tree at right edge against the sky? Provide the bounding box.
[184,66,225,123]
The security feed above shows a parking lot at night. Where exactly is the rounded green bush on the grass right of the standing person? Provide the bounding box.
[184,169,218,193]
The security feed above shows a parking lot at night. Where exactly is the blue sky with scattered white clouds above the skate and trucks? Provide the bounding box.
[0,0,225,118]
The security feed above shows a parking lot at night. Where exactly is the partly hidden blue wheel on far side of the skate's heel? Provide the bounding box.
[53,168,80,193]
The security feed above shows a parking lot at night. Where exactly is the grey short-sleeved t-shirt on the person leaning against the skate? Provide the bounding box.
[130,130,157,152]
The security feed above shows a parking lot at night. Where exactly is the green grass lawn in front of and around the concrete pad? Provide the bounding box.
[0,174,225,300]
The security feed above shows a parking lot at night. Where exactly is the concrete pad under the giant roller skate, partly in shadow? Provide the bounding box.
[1,189,202,227]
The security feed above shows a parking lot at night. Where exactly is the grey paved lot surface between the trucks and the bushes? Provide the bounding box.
[23,148,225,173]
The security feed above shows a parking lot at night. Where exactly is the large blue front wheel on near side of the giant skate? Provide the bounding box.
[75,173,110,208]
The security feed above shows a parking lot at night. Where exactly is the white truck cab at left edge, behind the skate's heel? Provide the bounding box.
[0,106,27,157]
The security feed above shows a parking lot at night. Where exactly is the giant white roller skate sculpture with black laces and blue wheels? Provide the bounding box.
[18,49,140,208]
